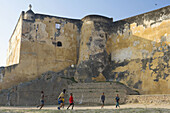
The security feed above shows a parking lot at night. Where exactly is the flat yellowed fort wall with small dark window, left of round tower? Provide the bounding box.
[20,15,79,80]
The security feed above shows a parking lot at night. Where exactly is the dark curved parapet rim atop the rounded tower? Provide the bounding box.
[81,15,113,23]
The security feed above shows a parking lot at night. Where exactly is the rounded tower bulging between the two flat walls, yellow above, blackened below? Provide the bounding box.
[75,15,112,82]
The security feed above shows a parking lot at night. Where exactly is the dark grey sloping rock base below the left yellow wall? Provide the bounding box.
[0,67,75,106]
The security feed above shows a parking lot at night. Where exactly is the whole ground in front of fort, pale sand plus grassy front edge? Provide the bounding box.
[0,104,170,113]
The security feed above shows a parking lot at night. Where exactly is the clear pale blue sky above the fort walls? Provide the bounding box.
[0,0,170,66]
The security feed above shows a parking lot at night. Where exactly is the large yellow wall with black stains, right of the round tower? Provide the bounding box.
[109,6,170,94]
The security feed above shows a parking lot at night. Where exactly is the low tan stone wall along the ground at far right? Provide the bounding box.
[126,95,170,105]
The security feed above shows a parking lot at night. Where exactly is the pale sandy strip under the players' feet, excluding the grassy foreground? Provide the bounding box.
[0,104,170,110]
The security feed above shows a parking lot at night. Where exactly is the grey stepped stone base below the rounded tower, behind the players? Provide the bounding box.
[67,82,138,105]
